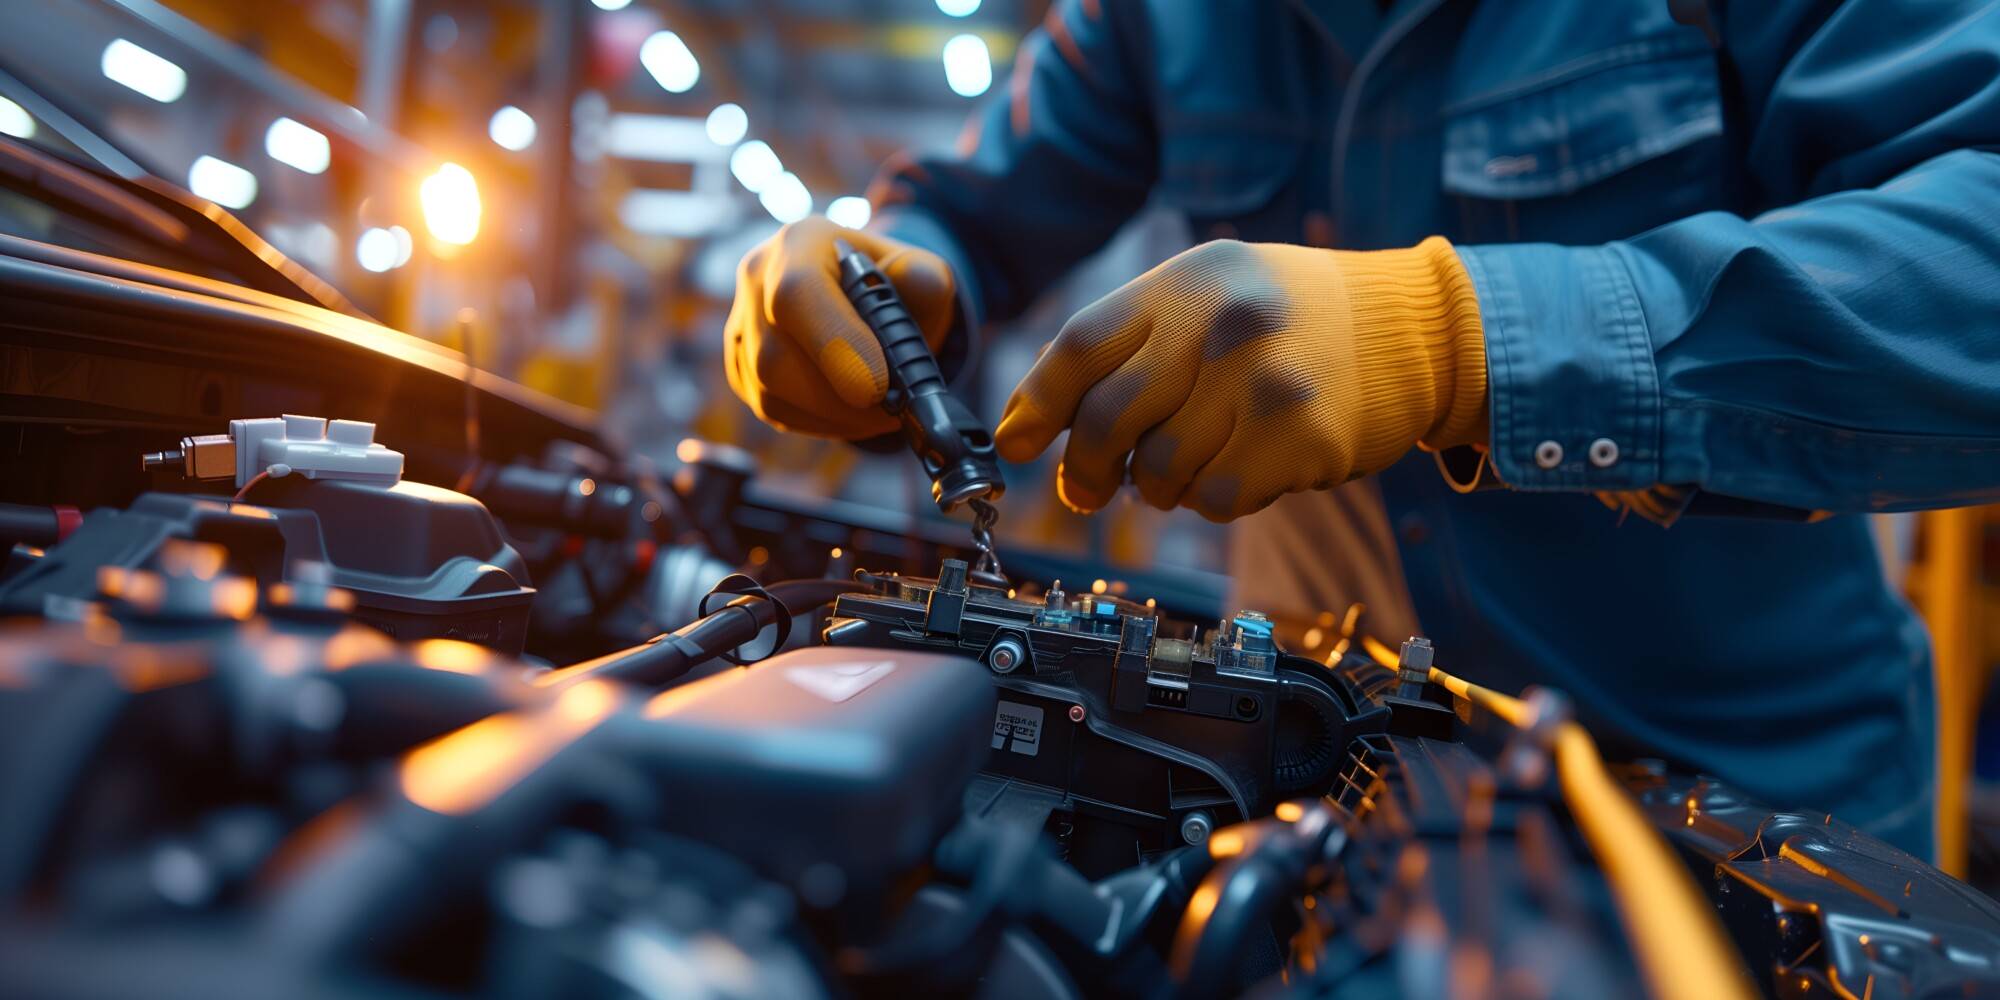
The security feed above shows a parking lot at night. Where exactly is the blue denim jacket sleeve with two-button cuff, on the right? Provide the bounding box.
[1460,0,2000,510]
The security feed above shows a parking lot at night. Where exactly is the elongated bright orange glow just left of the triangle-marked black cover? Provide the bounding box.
[400,680,618,814]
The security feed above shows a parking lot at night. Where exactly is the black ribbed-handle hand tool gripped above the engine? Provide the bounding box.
[834,240,1006,586]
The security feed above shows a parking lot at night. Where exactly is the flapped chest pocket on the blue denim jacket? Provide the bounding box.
[1442,46,1726,244]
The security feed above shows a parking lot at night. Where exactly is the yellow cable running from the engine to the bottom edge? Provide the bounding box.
[1362,636,1756,1000]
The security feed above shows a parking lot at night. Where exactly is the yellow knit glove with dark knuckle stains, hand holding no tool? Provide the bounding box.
[996,238,1486,520]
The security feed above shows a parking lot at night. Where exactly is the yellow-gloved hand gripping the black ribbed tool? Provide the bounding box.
[722,216,956,440]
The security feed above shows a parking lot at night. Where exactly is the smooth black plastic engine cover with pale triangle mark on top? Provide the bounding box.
[642,648,994,910]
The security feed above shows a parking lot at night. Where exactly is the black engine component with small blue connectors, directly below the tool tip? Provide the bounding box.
[824,560,1388,874]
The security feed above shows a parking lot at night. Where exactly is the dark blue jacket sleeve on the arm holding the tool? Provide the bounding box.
[870,0,1156,322]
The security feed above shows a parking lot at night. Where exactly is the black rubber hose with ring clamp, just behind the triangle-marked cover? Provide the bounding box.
[538,580,868,686]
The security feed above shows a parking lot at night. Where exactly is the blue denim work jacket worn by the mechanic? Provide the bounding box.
[874,0,2000,856]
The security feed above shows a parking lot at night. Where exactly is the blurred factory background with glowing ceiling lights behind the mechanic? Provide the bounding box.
[0,0,1222,570]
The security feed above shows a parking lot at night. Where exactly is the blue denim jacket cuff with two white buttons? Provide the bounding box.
[1458,244,1662,492]
